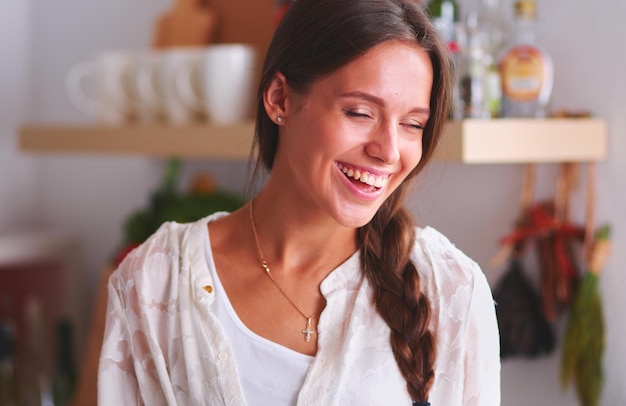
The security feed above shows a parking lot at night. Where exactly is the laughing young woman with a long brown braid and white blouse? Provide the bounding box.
[99,0,500,406]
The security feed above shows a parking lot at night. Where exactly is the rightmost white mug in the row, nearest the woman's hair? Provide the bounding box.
[175,44,257,125]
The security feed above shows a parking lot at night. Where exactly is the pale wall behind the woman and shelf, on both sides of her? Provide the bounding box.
[6,0,626,406]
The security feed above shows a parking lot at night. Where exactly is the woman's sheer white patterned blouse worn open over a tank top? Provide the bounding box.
[98,213,500,406]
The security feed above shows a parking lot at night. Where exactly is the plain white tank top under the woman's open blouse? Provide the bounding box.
[205,233,314,406]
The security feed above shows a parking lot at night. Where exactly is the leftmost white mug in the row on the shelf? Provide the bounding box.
[66,51,137,124]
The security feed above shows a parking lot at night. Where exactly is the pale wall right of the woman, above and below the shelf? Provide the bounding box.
[414,0,626,406]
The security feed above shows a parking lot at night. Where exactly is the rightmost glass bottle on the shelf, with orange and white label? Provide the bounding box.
[499,0,554,117]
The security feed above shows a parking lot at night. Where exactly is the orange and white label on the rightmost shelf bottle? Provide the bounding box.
[500,45,546,101]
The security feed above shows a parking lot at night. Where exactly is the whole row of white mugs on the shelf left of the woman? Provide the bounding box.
[66,44,258,125]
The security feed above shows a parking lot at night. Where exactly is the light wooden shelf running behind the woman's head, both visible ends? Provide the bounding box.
[19,118,607,164]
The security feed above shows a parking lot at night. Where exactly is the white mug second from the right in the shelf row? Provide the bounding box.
[158,47,204,124]
